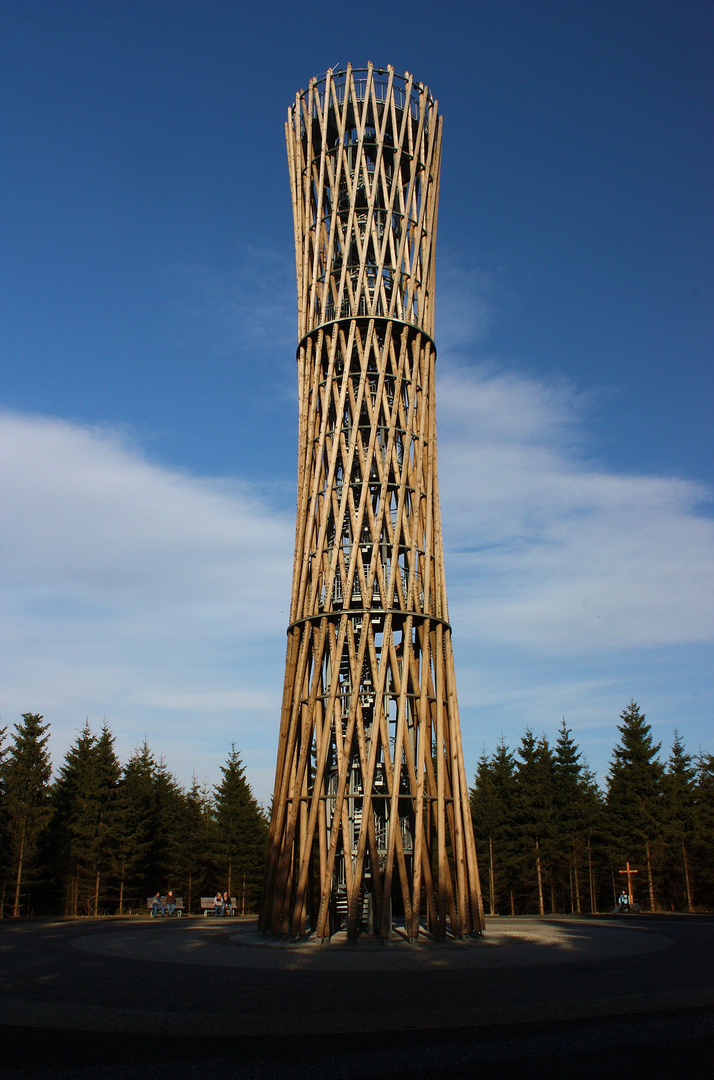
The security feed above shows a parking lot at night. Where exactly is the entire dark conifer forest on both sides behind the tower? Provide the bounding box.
[0,701,714,917]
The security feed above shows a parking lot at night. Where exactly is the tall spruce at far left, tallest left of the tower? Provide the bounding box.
[0,713,52,918]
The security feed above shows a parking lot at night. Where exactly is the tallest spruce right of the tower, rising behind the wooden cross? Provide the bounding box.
[607,701,664,910]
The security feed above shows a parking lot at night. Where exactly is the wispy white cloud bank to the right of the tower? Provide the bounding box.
[439,367,714,654]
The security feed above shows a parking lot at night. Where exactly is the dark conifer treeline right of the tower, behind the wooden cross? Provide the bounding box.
[471,701,714,915]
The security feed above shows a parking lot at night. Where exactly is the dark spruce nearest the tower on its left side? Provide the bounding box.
[215,743,268,909]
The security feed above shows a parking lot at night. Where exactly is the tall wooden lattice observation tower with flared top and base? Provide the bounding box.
[260,65,483,939]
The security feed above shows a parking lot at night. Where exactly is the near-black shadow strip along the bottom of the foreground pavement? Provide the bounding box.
[0,1009,714,1080]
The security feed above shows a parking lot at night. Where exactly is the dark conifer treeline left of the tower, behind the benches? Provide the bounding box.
[0,713,268,918]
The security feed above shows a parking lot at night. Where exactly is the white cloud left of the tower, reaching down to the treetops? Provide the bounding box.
[0,414,293,794]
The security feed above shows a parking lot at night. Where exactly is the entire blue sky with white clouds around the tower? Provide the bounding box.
[0,0,714,799]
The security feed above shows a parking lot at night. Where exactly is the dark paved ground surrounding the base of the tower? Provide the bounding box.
[0,916,714,1080]
